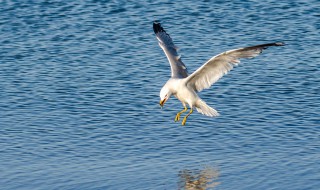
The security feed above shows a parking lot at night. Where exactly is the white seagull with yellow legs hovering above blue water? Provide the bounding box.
[153,21,285,125]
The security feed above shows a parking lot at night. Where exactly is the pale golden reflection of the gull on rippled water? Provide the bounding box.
[179,167,220,190]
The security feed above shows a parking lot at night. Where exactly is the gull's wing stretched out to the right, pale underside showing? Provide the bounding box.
[186,42,284,92]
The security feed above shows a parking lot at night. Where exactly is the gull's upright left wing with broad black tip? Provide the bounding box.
[153,22,188,78]
